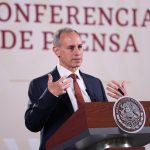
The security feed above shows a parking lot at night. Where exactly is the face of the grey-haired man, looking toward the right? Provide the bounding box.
[54,32,83,72]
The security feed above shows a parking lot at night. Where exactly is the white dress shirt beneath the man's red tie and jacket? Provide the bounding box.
[57,64,91,111]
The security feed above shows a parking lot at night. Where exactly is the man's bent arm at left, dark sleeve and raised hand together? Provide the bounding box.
[25,74,70,132]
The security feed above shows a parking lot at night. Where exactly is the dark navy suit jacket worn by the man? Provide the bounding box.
[25,68,107,150]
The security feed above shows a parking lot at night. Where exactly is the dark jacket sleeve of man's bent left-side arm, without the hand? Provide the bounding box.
[25,80,58,132]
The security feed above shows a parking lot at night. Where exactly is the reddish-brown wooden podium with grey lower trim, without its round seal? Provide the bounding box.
[46,101,150,150]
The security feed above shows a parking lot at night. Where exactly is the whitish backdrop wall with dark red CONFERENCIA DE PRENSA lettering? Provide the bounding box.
[0,0,150,150]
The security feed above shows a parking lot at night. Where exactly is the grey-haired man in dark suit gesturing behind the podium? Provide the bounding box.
[25,28,124,150]
